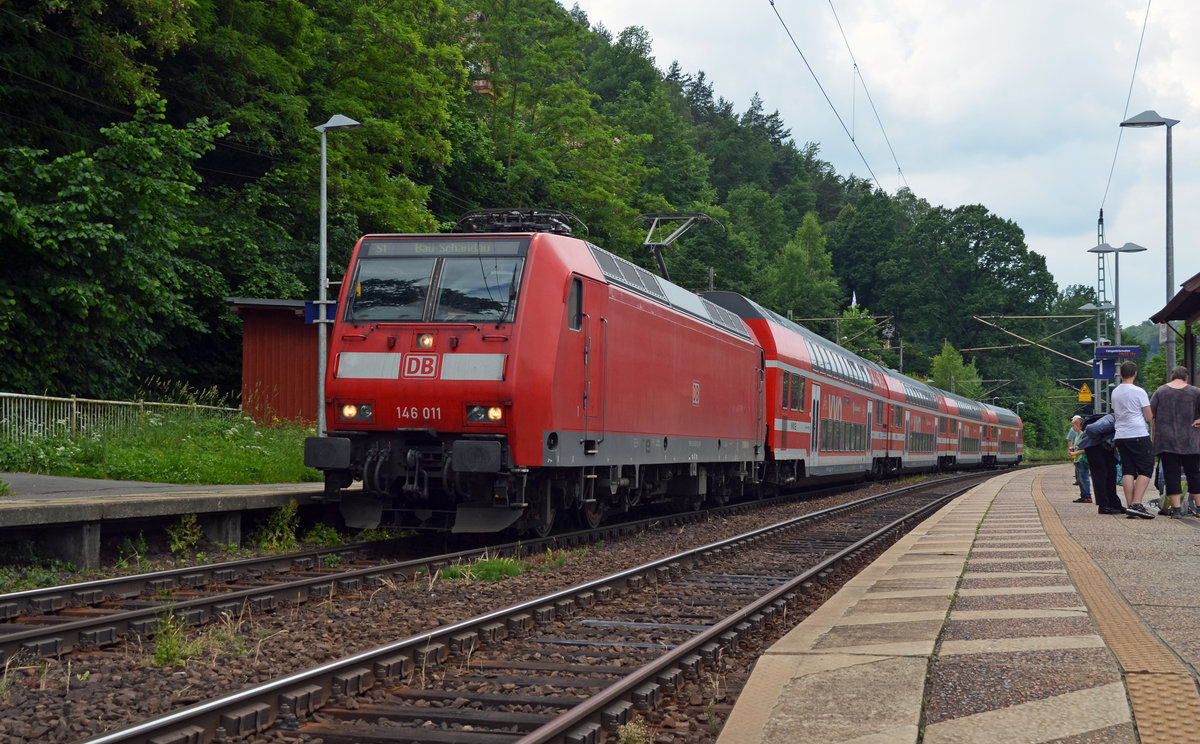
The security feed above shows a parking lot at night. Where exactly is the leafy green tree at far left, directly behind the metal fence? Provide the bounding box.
[0,101,224,397]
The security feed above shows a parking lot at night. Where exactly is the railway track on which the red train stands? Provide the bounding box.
[0,487,787,664]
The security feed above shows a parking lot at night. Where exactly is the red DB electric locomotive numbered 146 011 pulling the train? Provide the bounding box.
[305,210,764,534]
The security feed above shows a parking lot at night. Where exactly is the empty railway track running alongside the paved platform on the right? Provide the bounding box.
[68,475,982,744]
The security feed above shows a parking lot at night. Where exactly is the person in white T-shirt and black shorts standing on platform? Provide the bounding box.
[1112,361,1154,520]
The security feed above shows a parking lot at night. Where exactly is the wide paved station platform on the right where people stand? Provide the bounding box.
[718,464,1200,744]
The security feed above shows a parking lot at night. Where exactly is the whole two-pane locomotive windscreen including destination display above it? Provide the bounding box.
[344,239,529,323]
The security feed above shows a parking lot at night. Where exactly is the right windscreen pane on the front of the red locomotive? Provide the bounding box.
[433,256,524,323]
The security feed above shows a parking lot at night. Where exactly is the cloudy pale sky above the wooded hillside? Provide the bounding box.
[559,0,1200,337]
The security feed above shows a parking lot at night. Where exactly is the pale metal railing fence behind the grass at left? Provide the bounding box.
[0,392,239,442]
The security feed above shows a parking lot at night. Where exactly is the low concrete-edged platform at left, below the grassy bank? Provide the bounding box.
[0,473,324,570]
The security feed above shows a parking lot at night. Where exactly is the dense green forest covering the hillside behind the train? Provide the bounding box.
[0,0,1161,444]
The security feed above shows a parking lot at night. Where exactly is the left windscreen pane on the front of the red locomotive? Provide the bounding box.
[346,258,434,322]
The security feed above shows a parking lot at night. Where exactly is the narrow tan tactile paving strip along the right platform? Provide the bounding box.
[1033,475,1200,744]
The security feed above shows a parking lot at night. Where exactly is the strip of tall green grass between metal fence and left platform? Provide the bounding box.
[0,409,320,493]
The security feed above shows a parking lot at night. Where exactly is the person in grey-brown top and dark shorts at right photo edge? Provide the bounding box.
[1150,367,1200,518]
